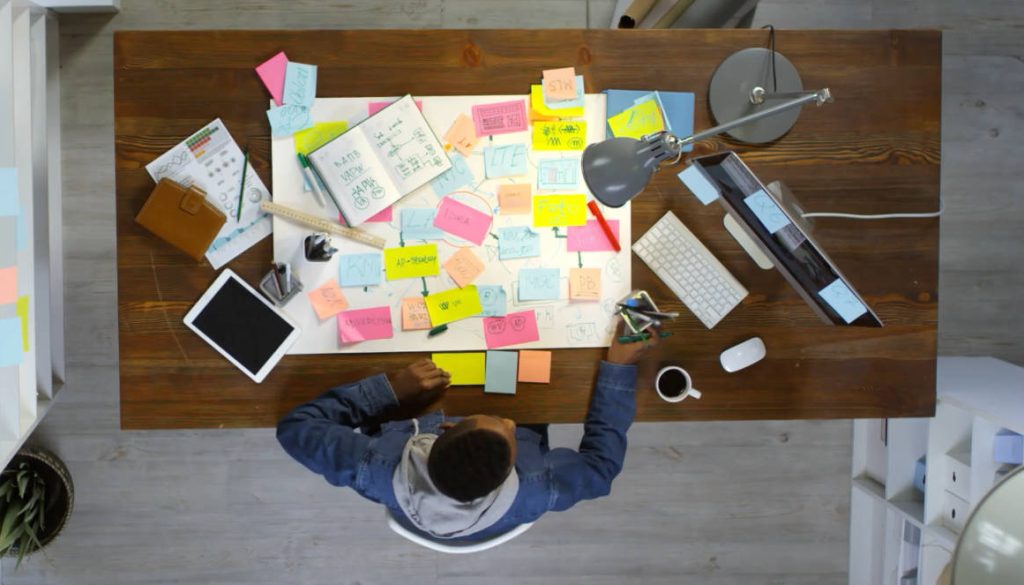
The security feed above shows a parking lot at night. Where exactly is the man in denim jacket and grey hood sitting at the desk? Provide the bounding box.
[278,323,657,541]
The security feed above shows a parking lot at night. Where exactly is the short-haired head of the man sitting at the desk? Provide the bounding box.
[427,414,515,502]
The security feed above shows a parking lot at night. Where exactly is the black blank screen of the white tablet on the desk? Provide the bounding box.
[193,278,293,375]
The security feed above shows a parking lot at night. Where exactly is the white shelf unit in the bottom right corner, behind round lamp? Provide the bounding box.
[849,358,1024,585]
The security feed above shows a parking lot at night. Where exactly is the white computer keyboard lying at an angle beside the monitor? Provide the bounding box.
[633,211,746,329]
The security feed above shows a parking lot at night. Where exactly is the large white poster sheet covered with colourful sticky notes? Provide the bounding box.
[272,93,632,353]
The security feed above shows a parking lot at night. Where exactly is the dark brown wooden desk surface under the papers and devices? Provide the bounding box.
[112,30,941,428]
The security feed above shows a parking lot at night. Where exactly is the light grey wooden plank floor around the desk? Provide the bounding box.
[3,0,1024,585]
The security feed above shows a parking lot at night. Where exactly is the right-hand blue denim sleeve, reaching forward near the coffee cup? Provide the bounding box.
[545,362,637,511]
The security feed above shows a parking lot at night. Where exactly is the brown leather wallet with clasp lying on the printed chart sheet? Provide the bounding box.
[135,178,227,262]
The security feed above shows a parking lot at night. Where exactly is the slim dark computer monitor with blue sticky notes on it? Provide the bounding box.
[689,152,882,327]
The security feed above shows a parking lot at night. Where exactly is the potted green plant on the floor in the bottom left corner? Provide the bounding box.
[0,449,75,567]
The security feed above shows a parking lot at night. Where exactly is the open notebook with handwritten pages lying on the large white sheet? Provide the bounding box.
[309,95,452,225]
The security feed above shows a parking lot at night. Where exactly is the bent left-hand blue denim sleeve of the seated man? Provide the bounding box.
[278,374,398,486]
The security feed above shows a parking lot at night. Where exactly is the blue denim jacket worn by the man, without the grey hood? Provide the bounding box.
[278,362,636,540]
